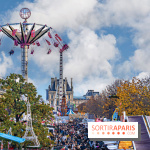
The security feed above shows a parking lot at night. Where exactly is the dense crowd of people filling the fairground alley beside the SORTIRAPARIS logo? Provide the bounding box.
[54,119,107,150]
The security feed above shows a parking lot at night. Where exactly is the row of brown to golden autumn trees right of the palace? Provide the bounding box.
[78,78,150,119]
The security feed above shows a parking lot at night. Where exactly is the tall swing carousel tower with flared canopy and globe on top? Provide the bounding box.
[1,8,52,82]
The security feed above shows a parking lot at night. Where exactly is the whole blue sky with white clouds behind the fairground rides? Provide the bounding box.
[0,0,150,99]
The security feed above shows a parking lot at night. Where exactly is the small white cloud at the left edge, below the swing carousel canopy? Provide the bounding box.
[0,51,13,77]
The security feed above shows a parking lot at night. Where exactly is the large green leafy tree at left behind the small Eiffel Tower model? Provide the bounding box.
[0,74,53,146]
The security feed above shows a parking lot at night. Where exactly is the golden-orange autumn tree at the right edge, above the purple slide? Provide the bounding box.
[116,78,150,115]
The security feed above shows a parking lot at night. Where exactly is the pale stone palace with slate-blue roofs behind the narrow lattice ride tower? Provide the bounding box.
[46,77,99,111]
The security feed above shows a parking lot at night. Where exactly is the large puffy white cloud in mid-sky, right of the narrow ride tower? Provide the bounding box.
[64,28,119,93]
